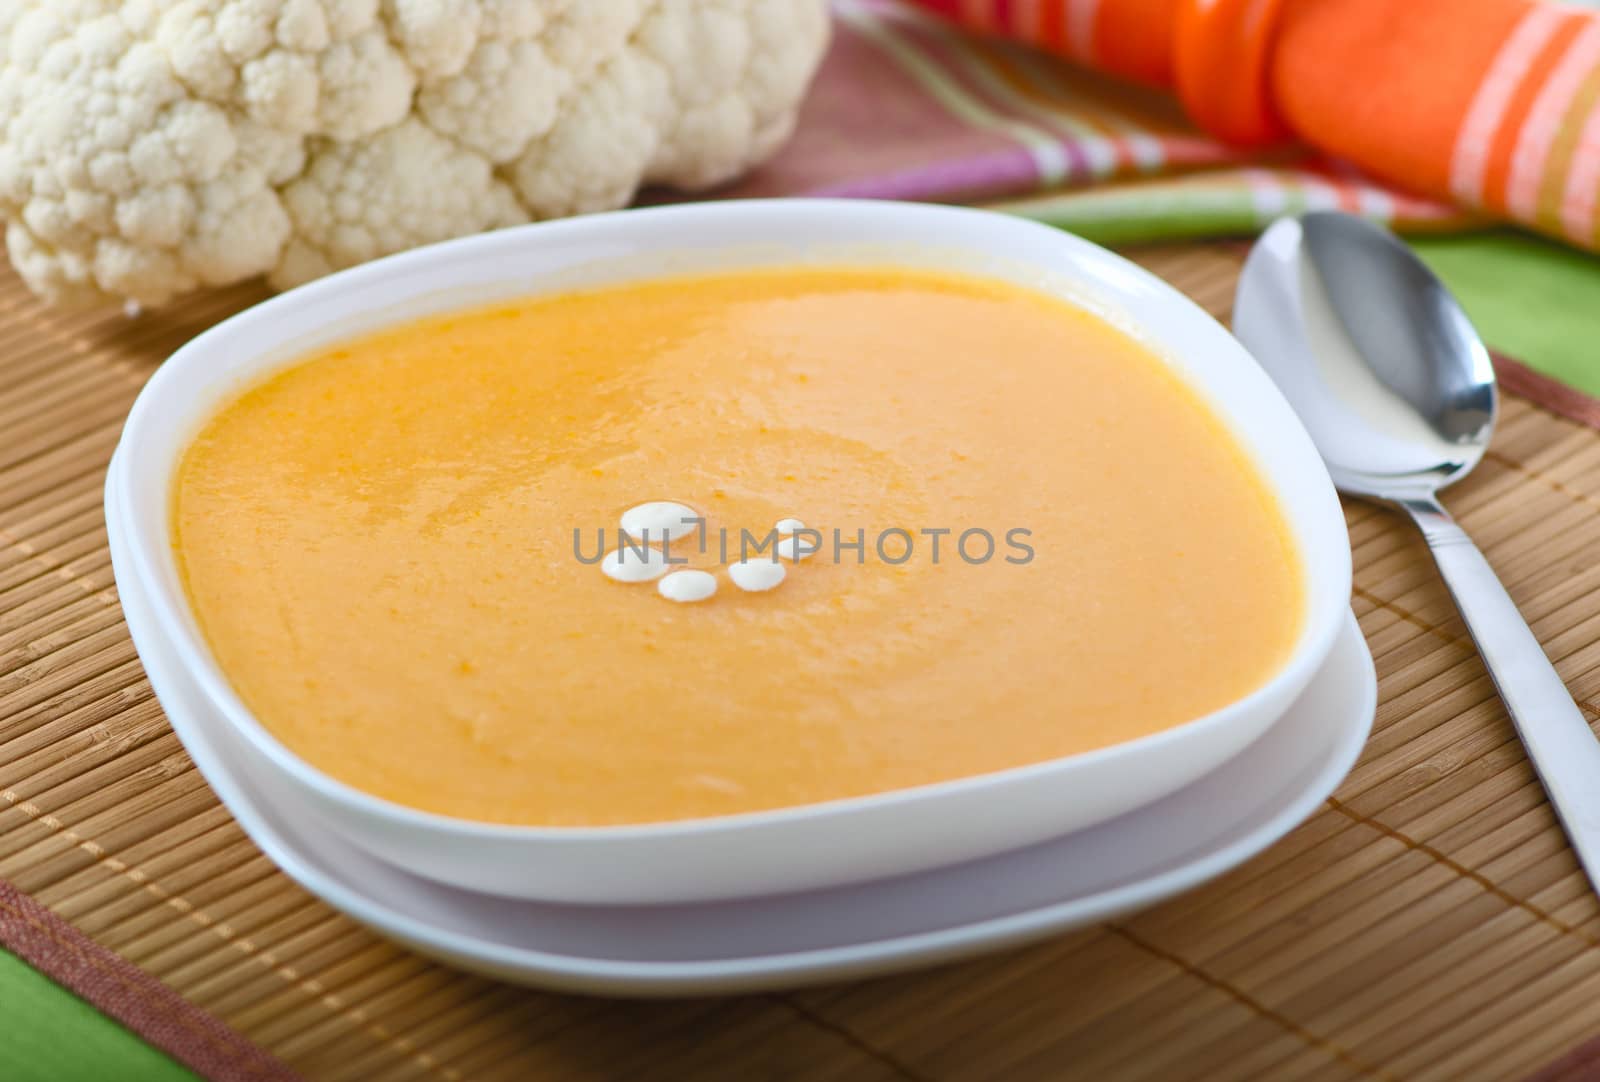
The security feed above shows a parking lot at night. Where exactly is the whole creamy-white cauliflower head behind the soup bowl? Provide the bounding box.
[0,0,827,304]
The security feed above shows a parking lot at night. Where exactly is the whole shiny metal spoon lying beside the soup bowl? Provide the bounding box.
[1234,211,1600,890]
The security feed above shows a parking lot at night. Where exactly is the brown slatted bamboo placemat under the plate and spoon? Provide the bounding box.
[0,245,1600,1082]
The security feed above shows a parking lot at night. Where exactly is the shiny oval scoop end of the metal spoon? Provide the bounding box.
[1234,211,1498,499]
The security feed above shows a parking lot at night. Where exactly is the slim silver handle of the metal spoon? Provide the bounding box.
[1400,496,1600,890]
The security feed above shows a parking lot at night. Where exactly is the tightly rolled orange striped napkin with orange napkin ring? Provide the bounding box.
[883,0,1600,250]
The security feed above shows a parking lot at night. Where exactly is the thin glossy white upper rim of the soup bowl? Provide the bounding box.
[106,198,1352,845]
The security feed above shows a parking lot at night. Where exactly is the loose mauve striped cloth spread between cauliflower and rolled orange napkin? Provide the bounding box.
[726,0,1472,243]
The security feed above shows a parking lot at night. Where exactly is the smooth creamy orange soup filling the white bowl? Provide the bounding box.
[173,267,1304,826]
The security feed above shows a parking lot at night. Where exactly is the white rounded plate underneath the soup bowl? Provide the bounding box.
[122,512,1378,996]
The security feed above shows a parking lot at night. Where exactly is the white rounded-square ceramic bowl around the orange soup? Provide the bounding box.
[106,200,1350,903]
